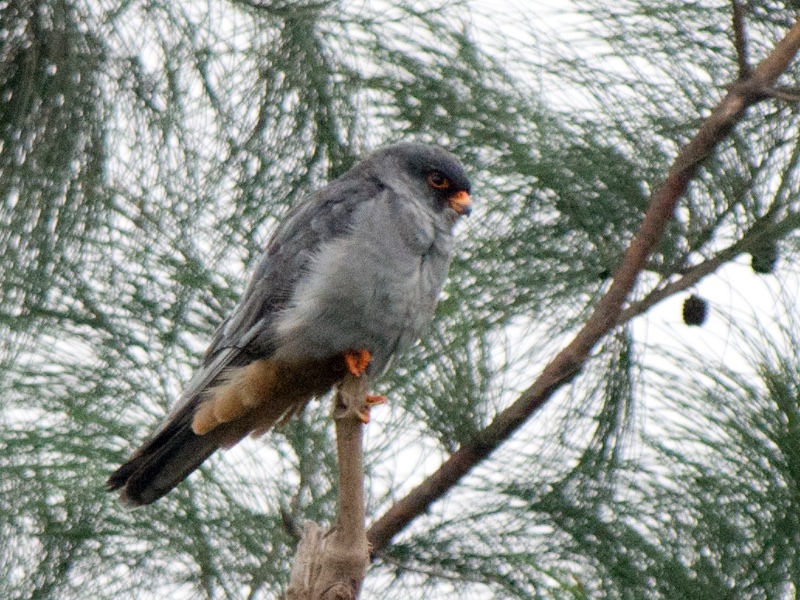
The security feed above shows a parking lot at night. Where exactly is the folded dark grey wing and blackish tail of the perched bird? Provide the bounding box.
[108,173,381,506]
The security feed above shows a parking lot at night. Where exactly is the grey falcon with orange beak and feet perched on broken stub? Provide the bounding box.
[106,142,472,508]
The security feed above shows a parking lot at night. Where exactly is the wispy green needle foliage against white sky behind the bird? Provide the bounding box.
[0,0,800,599]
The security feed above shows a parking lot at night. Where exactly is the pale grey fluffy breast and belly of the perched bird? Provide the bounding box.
[275,200,452,372]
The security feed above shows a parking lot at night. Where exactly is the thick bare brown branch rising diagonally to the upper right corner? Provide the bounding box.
[367,20,800,552]
